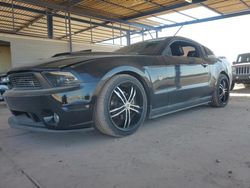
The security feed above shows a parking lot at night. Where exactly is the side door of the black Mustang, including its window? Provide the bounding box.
[163,40,210,108]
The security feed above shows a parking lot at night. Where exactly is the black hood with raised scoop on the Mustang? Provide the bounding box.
[8,52,126,74]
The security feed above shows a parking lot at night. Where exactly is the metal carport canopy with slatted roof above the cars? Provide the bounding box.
[0,0,250,44]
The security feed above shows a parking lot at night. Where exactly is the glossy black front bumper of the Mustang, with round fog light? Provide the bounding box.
[4,83,96,130]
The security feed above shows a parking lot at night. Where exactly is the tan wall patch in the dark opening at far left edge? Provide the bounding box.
[0,45,11,74]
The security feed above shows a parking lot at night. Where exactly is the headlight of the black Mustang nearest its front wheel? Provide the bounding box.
[43,71,79,87]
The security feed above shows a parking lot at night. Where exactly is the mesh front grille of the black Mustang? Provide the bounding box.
[9,73,41,89]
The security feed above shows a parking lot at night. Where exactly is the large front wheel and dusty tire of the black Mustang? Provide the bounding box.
[94,74,147,137]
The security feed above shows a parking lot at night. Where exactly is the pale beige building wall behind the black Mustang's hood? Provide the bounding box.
[0,33,119,67]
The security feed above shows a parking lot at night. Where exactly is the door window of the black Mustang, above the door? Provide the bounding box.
[170,41,201,57]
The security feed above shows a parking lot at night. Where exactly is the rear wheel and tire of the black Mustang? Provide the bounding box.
[210,74,230,107]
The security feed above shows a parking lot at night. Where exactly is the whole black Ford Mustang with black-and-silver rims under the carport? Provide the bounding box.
[4,37,232,136]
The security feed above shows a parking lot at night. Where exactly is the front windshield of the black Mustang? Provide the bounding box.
[115,38,165,55]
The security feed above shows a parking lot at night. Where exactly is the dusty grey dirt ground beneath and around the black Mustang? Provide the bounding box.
[0,87,250,188]
